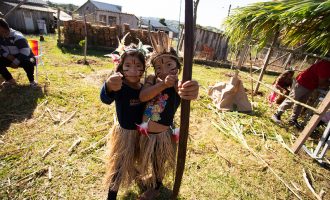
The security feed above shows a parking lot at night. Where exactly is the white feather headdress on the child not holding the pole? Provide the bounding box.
[104,32,151,65]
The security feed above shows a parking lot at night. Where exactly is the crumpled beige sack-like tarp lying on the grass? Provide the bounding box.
[208,76,252,112]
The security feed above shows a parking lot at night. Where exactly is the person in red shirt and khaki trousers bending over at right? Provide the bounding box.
[272,60,330,129]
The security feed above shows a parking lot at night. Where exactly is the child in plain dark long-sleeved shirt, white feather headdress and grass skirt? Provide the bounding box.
[101,33,150,199]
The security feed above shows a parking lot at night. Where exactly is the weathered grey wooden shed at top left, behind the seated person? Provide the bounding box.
[0,0,55,33]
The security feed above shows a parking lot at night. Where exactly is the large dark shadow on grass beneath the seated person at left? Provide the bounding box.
[0,85,44,135]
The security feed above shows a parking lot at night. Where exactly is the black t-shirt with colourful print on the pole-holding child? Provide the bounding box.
[144,87,181,126]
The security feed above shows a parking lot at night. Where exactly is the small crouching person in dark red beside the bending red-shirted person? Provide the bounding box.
[268,70,294,104]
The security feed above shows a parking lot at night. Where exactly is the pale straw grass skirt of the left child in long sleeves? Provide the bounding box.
[105,125,139,191]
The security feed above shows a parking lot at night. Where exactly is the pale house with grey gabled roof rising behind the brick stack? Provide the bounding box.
[75,0,139,28]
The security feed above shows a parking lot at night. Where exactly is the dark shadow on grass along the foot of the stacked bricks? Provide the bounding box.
[58,45,115,58]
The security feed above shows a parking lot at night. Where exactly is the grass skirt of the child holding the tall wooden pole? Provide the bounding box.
[138,129,177,187]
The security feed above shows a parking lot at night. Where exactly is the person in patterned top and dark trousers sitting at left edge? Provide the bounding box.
[0,18,37,86]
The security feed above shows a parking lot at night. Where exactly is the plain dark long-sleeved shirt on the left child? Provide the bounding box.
[101,83,146,130]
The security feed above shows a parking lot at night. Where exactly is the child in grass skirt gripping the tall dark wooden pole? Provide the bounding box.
[138,34,199,199]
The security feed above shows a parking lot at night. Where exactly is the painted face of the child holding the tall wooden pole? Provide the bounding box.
[154,56,179,80]
